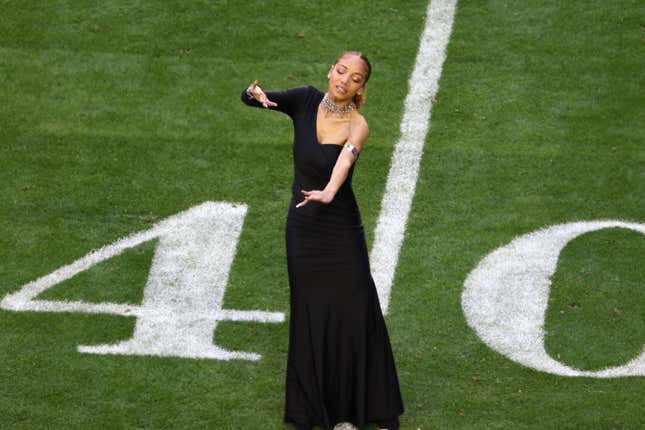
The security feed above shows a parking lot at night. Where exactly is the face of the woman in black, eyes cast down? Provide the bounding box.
[327,55,367,102]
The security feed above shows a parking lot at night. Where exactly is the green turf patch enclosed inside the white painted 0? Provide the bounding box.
[546,229,645,370]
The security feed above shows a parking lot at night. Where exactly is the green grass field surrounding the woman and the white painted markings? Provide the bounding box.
[0,0,645,430]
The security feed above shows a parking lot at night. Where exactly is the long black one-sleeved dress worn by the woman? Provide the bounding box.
[242,86,403,430]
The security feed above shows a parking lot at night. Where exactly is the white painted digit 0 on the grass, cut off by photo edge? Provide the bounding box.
[462,221,645,378]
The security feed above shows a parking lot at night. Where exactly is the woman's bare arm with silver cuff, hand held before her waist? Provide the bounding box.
[296,116,369,208]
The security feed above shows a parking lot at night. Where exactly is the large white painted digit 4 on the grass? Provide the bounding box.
[0,202,284,360]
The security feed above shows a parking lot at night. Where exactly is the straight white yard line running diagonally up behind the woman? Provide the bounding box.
[370,0,457,315]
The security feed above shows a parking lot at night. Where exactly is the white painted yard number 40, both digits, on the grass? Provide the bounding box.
[0,202,645,378]
